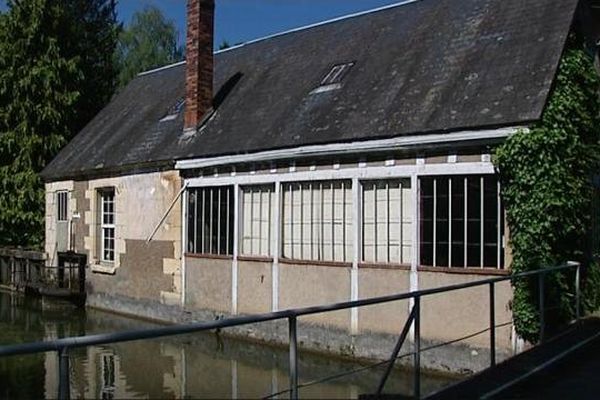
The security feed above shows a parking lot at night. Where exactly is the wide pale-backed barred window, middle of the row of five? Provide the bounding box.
[282,181,352,262]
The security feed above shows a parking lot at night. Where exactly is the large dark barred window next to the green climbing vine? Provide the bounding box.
[420,175,504,268]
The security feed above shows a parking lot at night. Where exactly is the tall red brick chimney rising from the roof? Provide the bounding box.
[183,0,215,131]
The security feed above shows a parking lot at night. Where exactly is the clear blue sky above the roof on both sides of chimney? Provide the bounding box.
[118,0,401,45]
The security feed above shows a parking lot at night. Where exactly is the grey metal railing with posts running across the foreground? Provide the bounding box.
[0,262,581,399]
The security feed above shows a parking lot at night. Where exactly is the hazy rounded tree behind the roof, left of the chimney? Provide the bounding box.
[116,6,183,87]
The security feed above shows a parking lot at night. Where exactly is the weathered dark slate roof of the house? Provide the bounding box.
[43,0,577,180]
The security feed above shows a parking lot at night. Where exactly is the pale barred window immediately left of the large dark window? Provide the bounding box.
[362,179,413,264]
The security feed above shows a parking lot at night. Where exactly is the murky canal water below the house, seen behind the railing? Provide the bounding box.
[0,292,455,399]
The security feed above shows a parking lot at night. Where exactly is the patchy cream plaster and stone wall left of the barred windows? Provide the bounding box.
[46,171,182,305]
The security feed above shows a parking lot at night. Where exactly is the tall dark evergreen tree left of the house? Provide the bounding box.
[0,0,119,246]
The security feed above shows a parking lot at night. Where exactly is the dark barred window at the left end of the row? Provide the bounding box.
[187,186,234,255]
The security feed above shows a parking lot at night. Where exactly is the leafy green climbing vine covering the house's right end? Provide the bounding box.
[495,34,600,342]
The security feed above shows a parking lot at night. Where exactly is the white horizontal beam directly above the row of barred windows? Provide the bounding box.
[187,162,495,187]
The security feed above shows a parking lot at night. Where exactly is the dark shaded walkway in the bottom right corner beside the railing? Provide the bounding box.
[428,317,600,400]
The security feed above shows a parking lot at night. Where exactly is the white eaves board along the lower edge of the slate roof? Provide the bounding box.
[175,127,524,169]
